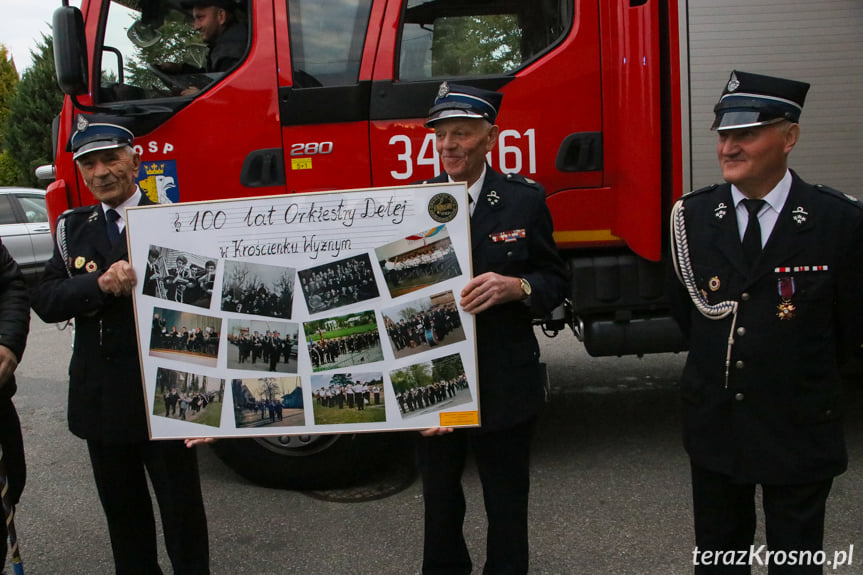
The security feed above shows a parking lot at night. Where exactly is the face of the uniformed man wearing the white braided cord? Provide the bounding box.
[716,122,800,198]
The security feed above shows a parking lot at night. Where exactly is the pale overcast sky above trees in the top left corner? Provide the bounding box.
[0,0,81,75]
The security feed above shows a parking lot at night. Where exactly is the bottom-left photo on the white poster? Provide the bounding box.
[151,367,225,427]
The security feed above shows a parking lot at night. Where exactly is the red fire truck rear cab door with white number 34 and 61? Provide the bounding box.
[370,0,602,198]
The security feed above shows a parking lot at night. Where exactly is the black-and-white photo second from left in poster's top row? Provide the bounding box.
[222,260,296,319]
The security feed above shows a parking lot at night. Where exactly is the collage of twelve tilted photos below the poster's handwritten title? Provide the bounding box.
[136,205,476,437]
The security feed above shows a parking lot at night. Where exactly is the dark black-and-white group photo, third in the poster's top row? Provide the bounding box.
[298,254,380,314]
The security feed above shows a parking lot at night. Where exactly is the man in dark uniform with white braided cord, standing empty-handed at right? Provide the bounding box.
[671,71,863,575]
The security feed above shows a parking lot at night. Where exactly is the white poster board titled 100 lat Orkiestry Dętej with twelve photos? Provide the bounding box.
[126,184,479,439]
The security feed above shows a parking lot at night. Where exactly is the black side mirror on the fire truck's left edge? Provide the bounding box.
[53,6,90,96]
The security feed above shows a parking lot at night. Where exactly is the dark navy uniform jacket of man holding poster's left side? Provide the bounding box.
[31,195,152,443]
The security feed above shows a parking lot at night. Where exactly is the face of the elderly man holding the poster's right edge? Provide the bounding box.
[434,118,498,186]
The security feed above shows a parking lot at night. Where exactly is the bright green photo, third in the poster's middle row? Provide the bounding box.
[303,311,384,371]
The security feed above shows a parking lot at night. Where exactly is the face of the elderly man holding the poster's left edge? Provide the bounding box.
[77,147,141,208]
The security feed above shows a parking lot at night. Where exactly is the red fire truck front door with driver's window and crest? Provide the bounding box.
[68,0,285,205]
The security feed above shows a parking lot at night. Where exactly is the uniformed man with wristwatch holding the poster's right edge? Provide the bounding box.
[418,83,567,575]
